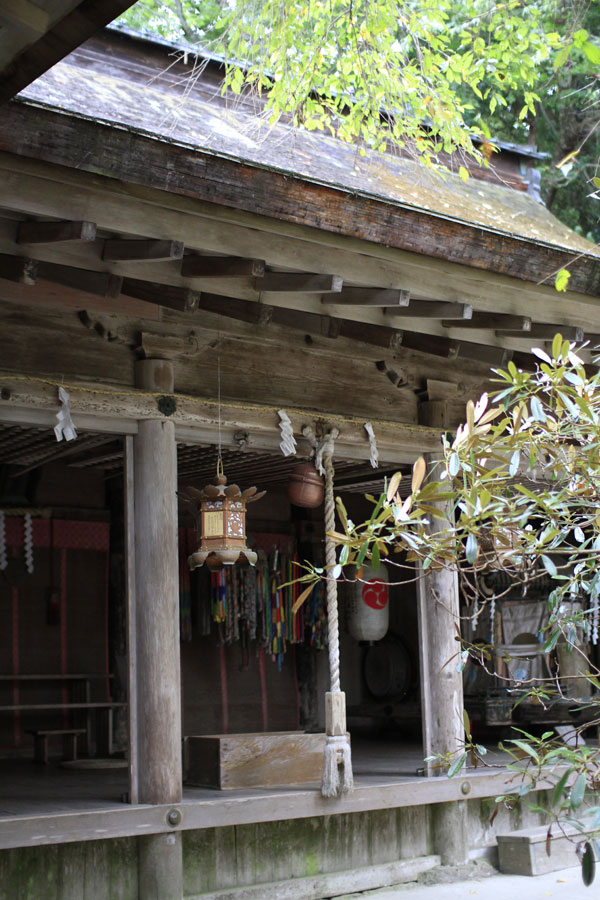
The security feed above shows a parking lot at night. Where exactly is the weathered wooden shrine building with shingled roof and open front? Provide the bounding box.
[0,19,600,900]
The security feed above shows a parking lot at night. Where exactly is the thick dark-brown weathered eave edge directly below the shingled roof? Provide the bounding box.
[0,102,600,296]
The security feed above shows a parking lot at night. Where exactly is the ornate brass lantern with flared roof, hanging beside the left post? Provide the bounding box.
[183,460,266,569]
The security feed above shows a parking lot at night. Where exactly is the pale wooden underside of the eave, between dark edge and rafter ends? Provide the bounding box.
[0,152,600,343]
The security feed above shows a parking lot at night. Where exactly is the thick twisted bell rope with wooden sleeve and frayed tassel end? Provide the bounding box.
[321,444,354,797]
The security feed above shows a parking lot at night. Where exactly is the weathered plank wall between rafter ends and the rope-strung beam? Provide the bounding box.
[0,285,489,424]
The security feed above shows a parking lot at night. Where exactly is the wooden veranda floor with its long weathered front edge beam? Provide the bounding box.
[0,740,524,849]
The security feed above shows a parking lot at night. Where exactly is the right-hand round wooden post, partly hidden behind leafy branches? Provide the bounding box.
[417,455,468,864]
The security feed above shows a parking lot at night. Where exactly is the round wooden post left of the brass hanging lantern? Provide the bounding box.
[131,359,183,900]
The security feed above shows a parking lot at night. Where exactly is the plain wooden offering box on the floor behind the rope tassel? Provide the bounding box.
[185,731,325,790]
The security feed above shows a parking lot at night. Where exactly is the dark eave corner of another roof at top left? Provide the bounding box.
[0,0,133,103]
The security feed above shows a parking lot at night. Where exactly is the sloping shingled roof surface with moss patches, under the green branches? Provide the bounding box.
[20,25,600,258]
